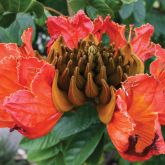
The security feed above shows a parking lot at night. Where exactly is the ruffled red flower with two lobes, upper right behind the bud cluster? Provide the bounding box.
[105,17,155,61]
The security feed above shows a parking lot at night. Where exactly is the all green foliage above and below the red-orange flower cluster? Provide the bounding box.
[0,0,165,165]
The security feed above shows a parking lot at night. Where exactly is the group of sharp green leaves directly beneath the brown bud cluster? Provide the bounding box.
[21,104,105,165]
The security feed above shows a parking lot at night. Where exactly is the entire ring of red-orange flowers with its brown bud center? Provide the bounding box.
[0,11,165,161]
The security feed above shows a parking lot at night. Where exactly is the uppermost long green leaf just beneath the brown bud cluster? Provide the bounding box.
[21,104,99,150]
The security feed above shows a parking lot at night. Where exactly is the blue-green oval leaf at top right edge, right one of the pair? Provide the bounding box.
[133,0,146,23]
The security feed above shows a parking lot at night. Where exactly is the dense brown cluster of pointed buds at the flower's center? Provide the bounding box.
[48,36,143,105]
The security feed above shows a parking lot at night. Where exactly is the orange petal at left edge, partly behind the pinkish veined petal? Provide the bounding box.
[0,57,23,127]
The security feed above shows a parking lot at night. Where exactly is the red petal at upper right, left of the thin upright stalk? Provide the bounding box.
[105,17,127,49]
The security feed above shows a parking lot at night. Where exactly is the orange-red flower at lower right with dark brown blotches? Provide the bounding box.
[107,75,165,161]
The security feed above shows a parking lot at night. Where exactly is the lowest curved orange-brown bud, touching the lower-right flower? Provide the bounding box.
[97,86,116,124]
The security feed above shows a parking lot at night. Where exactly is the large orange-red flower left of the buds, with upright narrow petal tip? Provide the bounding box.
[0,28,62,138]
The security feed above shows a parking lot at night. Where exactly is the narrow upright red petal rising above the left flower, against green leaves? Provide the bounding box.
[20,27,35,57]
